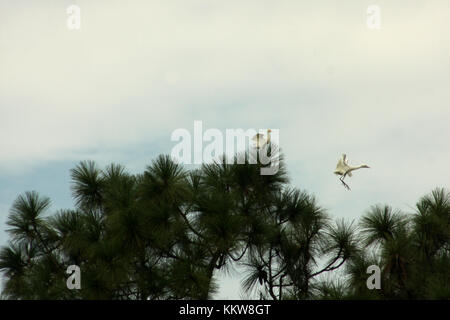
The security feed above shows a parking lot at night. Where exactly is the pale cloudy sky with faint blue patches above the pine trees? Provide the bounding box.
[0,0,450,299]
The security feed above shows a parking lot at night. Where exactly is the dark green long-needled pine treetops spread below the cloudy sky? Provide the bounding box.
[0,150,450,299]
